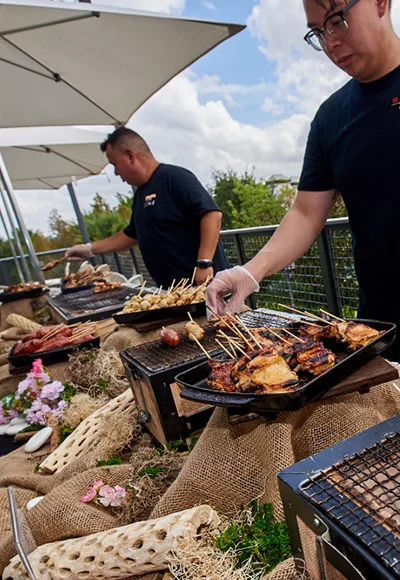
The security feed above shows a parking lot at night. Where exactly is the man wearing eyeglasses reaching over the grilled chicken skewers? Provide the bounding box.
[207,0,400,354]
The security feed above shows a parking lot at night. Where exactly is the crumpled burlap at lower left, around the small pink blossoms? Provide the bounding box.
[0,442,131,574]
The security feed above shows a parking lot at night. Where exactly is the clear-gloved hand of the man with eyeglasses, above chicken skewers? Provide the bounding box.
[206,266,260,318]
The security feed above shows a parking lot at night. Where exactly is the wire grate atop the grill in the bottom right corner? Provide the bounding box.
[300,432,400,578]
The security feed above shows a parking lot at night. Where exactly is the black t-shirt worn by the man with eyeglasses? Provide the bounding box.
[299,67,400,322]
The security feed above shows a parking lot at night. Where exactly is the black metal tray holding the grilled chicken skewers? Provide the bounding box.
[175,318,396,413]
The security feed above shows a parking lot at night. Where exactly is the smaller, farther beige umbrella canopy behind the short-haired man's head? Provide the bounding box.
[0,127,109,189]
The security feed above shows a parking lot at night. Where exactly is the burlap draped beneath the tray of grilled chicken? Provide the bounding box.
[151,379,400,579]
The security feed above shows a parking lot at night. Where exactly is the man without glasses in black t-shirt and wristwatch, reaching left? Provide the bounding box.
[66,127,229,288]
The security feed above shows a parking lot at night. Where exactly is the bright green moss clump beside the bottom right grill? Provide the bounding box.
[215,501,292,574]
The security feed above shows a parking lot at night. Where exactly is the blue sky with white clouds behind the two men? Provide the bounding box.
[7,0,400,235]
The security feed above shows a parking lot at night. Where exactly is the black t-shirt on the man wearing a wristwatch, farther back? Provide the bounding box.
[124,163,229,288]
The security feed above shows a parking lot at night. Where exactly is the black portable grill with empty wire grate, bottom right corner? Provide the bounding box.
[278,415,400,580]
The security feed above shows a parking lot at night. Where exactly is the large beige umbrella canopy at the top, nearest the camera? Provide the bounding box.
[0,0,244,127]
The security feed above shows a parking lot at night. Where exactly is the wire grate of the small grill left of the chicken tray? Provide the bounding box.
[124,324,220,372]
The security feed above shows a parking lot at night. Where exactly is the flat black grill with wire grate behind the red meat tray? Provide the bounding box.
[49,286,145,324]
